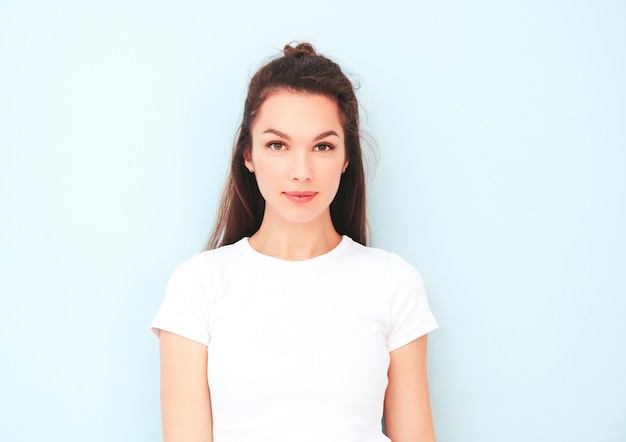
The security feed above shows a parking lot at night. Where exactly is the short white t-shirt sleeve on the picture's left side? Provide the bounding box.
[150,254,212,345]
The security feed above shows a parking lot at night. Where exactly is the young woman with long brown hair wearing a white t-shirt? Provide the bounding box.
[152,43,437,442]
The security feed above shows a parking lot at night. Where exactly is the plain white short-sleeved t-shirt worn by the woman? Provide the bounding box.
[152,236,437,442]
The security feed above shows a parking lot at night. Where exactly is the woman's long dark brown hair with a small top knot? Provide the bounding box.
[206,43,368,250]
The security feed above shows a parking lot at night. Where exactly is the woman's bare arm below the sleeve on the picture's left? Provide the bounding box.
[159,330,213,442]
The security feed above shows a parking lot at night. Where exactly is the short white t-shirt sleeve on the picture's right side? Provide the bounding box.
[387,253,439,351]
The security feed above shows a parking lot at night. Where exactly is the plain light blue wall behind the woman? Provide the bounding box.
[0,0,626,442]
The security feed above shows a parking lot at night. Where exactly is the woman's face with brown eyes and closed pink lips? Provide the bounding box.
[244,91,348,223]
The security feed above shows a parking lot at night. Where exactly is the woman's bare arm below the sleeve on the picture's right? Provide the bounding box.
[384,335,435,442]
